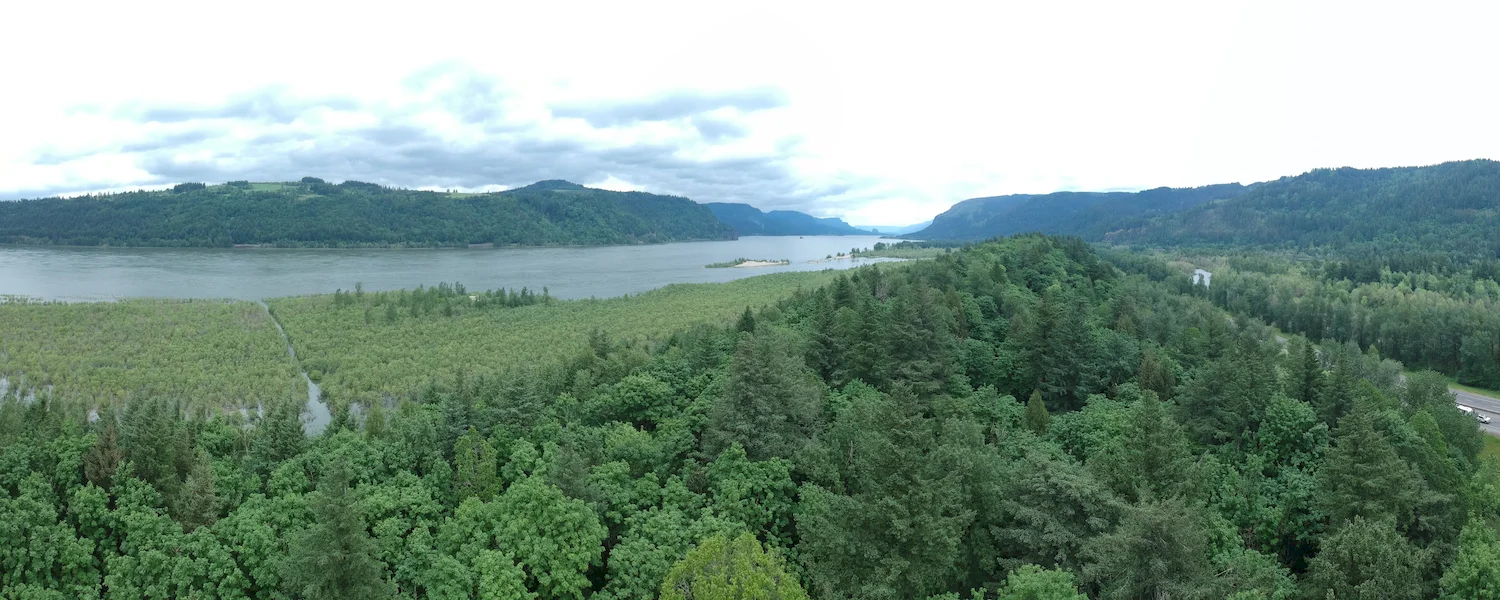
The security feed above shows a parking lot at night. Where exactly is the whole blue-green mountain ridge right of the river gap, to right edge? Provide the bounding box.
[903,159,1500,258]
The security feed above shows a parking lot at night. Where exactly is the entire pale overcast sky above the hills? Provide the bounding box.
[0,0,1500,225]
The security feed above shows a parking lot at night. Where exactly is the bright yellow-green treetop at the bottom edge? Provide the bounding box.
[662,534,807,600]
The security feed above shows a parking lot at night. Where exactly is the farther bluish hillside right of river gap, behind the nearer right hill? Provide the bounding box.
[903,183,1247,240]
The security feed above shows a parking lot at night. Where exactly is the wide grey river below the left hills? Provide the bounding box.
[0,236,900,302]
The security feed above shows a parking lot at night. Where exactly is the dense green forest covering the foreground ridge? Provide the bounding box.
[0,236,1500,600]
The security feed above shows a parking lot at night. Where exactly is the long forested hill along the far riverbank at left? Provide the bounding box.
[0,177,735,248]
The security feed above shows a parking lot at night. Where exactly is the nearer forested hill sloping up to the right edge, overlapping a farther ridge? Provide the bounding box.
[1106,161,1500,258]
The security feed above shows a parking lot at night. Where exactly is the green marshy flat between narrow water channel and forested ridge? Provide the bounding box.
[270,270,837,404]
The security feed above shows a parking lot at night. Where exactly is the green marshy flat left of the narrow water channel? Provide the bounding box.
[0,300,306,407]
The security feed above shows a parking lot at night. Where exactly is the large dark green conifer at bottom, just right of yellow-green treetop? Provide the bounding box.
[797,387,974,599]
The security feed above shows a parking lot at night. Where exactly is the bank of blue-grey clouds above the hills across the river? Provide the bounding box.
[6,63,849,212]
